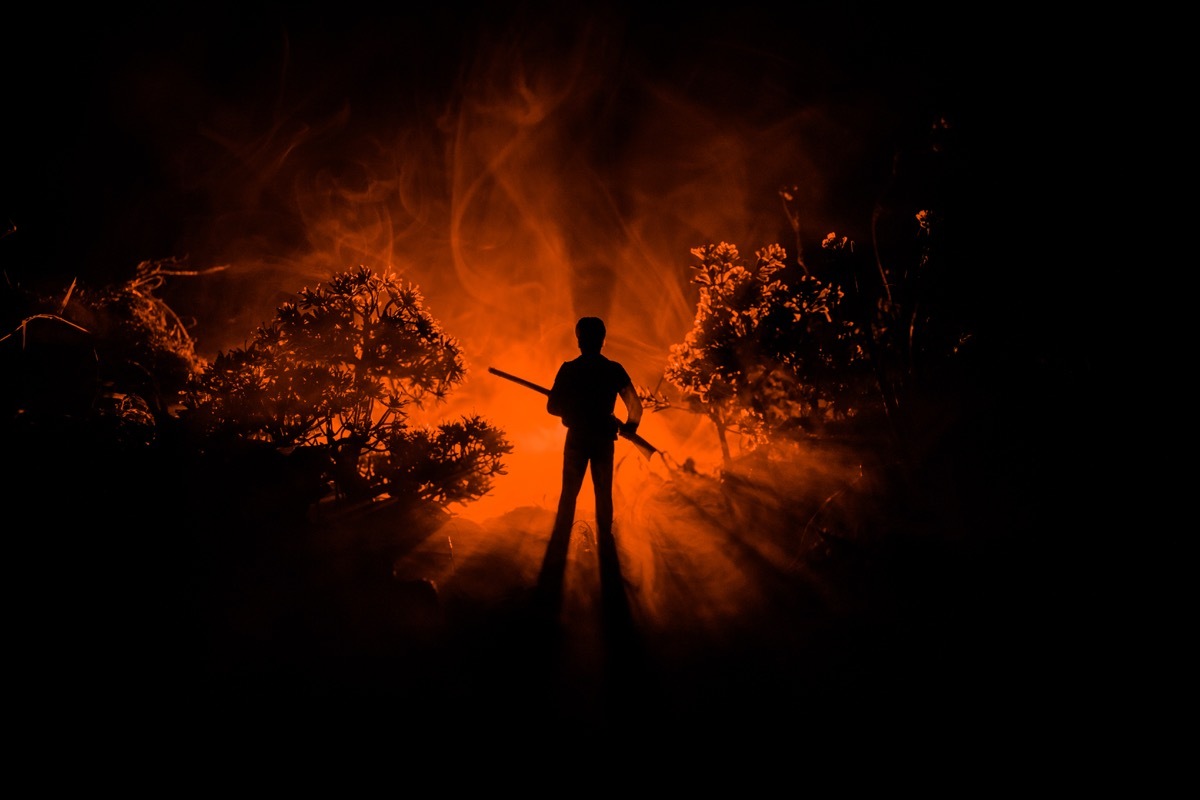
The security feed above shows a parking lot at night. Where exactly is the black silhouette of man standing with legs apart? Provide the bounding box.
[546,317,642,536]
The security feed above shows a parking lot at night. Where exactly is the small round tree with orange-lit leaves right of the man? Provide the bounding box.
[665,242,863,467]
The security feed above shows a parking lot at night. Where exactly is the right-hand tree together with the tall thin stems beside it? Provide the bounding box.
[662,118,985,469]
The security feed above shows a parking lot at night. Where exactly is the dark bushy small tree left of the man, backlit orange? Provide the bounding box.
[185,266,512,506]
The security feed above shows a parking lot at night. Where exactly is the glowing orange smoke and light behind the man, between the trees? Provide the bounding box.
[162,17,864,519]
